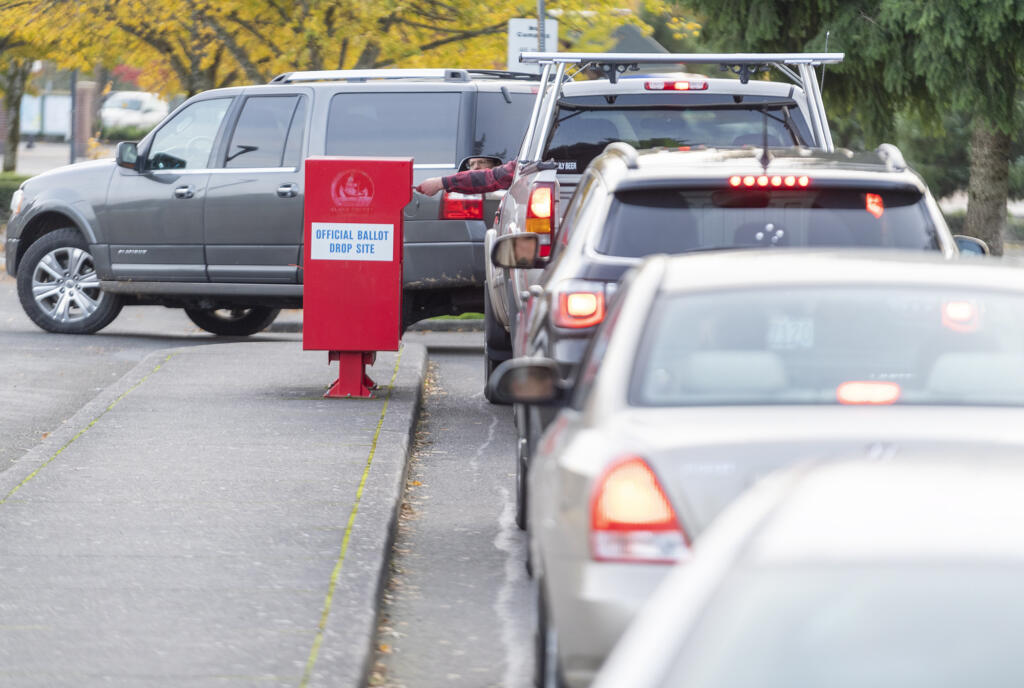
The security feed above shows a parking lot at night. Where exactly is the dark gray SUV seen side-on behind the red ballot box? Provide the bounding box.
[6,70,537,335]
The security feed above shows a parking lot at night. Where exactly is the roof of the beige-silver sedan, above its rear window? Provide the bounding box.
[647,248,1024,293]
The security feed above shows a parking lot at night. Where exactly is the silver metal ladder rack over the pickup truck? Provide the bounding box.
[519,52,845,158]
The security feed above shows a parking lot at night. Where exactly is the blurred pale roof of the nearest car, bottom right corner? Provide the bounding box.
[742,448,1024,566]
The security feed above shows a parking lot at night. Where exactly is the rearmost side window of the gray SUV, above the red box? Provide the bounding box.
[326,93,460,162]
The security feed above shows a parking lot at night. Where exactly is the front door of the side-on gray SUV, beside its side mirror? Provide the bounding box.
[98,96,233,282]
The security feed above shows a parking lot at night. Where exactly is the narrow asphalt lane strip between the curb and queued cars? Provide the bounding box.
[370,354,534,688]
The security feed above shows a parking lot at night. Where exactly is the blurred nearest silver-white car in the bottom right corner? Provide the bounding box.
[593,452,1024,688]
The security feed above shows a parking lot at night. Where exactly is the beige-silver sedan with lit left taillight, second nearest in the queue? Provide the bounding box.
[492,251,1024,686]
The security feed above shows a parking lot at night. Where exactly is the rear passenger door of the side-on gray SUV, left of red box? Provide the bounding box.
[203,91,309,284]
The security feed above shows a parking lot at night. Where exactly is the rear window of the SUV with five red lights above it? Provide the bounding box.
[597,188,938,258]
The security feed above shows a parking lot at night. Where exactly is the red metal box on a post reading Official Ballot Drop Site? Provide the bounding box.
[302,157,413,397]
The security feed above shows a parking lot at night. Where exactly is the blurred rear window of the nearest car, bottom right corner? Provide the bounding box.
[662,562,1024,688]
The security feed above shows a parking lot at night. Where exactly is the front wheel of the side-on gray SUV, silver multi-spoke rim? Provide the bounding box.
[17,227,124,335]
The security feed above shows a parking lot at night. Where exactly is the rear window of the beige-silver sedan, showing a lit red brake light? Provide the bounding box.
[630,286,1024,406]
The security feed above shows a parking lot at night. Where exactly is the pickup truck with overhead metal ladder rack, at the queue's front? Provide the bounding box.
[484,53,843,398]
